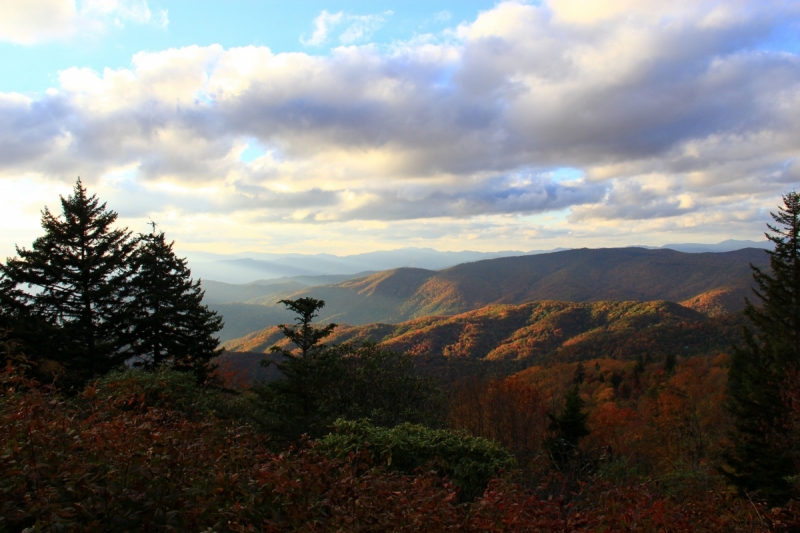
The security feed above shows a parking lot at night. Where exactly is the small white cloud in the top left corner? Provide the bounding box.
[0,0,169,45]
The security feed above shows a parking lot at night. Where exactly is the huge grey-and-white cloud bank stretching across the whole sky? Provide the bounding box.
[0,0,800,255]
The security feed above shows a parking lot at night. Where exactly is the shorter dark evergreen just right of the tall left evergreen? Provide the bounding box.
[127,224,222,382]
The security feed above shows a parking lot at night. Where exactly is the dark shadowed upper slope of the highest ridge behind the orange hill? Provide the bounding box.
[409,248,768,316]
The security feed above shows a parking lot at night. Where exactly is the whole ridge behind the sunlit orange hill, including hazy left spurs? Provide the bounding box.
[212,248,768,340]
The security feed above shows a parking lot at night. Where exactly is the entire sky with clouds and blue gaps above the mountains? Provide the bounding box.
[0,0,800,257]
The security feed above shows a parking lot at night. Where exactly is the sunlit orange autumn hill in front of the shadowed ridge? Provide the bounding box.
[220,301,741,364]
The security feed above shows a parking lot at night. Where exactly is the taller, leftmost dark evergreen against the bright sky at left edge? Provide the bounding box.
[0,178,135,383]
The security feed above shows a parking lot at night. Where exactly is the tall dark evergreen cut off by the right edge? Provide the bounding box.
[726,191,800,504]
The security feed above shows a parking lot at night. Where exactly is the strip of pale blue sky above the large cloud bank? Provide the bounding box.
[0,0,495,92]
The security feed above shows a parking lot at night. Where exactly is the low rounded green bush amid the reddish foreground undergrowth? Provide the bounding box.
[317,419,517,499]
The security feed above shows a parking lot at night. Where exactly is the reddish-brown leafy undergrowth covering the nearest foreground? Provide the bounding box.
[0,364,800,532]
